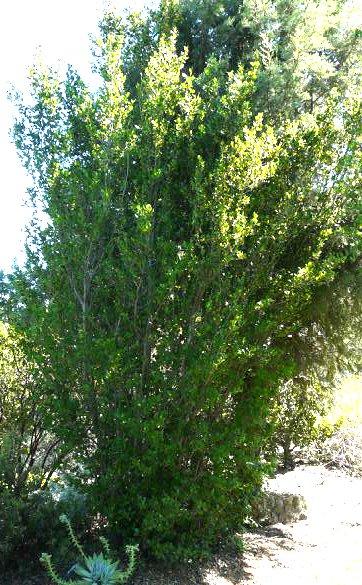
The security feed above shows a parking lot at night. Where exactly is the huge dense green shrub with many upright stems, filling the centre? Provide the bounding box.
[2,1,361,558]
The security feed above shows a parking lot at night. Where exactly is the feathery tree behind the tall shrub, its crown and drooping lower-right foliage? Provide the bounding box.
[152,0,362,464]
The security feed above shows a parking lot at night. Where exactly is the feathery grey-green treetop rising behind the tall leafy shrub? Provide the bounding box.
[126,0,362,123]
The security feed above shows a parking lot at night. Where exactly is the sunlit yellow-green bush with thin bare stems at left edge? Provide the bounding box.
[0,324,64,497]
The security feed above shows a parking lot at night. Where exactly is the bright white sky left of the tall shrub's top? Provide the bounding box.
[0,0,154,271]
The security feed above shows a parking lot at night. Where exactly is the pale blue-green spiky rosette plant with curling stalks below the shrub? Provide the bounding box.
[40,514,138,585]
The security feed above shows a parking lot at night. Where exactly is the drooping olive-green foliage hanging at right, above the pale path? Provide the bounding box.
[270,272,362,467]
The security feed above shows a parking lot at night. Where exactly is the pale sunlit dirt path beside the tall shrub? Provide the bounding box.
[204,466,362,585]
